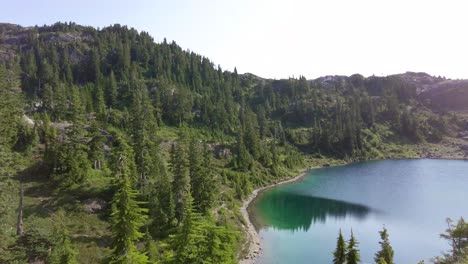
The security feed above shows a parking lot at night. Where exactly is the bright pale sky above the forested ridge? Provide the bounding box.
[0,0,468,79]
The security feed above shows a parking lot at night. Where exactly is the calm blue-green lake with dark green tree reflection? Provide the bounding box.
[248,159,468,264]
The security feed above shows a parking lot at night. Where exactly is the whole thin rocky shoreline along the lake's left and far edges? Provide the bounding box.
[239,156,467,264]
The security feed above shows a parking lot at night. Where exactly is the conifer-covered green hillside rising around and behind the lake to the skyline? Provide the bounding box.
[0,23,468,263]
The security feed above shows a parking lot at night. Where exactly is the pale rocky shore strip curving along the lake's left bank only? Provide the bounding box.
[239,169,312,264]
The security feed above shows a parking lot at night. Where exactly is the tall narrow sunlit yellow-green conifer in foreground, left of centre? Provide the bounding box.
[110,139,148,264]
